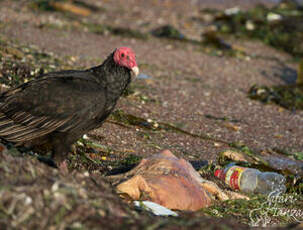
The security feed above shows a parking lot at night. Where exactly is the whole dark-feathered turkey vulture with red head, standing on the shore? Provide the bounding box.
[0,47,139,164]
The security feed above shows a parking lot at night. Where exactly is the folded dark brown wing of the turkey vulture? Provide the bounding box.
[0,71,106,142]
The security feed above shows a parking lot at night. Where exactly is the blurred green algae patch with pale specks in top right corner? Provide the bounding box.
[201,1,303,57]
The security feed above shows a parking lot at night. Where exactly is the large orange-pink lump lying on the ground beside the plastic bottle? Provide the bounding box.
[117,150,211,211]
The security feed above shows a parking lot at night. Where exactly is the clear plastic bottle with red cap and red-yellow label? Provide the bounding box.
[215,165,286,195]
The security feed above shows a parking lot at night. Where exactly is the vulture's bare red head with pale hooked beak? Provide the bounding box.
[114,47,139,76]
